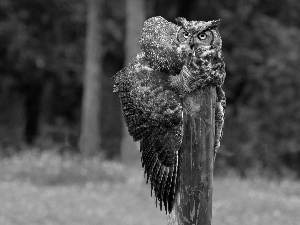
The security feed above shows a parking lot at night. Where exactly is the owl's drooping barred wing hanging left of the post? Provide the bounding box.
[114,53,182,212]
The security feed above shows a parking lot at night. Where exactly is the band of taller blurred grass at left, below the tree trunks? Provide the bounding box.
[0,151,126,186]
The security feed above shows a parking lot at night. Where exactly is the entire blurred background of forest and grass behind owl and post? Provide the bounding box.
[0,0,300,225]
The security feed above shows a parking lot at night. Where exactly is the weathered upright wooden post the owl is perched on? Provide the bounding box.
[168,87,216,225]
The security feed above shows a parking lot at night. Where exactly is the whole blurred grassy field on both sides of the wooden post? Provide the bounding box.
[0,152,300,225]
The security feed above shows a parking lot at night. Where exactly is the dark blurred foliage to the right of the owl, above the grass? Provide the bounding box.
[219,0,300,174]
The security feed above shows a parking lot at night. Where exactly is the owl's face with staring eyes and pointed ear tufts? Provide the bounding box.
[176,17,222,56]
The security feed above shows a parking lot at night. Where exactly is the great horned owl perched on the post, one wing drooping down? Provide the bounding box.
[114,17,225,212]
